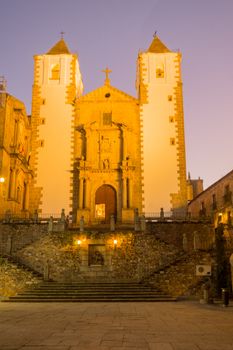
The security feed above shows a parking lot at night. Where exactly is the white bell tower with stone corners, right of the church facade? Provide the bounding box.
[137,35,187,215]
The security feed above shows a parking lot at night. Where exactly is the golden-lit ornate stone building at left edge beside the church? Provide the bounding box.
[0,80,33,218]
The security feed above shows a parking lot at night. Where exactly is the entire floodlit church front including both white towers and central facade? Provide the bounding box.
[0,36,187,224]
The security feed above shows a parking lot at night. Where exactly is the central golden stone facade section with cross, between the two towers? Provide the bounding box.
[73,73,142,222]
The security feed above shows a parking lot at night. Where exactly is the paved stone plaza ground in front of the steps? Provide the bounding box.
[0,302,233,350]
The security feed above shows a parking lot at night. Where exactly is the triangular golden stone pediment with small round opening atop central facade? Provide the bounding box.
[77,85,138,103]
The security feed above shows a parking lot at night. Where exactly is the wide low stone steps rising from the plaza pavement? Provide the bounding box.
[4,282,176,302]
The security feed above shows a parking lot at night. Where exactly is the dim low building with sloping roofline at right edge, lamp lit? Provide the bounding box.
[188,170,233,226]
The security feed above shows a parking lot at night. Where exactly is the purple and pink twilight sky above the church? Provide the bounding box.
[0,0,233,188]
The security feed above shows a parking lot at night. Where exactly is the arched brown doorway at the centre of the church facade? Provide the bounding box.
[95,185,117,222]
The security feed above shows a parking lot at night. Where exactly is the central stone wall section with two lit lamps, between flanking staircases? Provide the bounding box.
[14,231,179,282]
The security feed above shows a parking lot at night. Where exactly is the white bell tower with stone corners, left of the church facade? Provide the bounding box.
[30,37,83,215]
